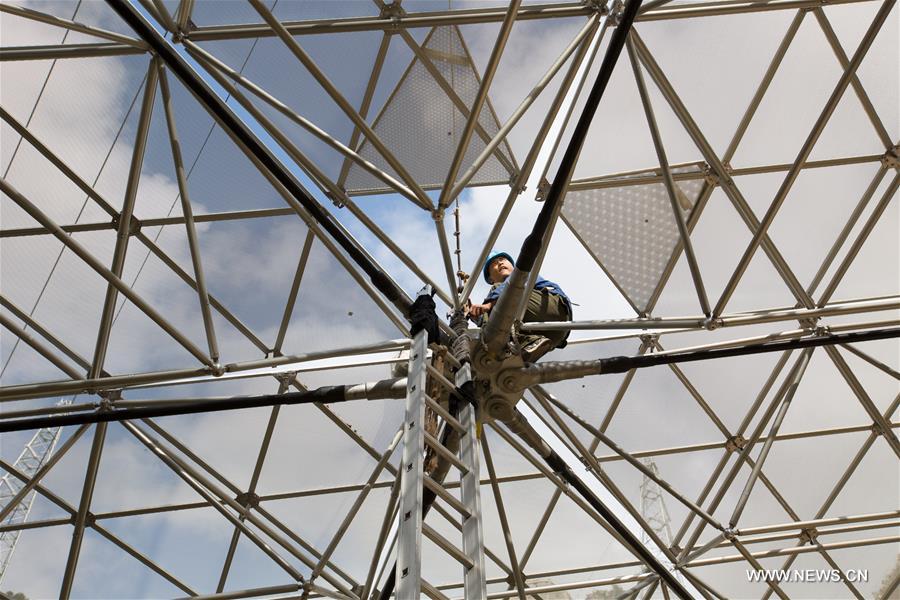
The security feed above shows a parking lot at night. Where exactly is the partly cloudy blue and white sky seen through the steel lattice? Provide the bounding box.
[0,0,900,598]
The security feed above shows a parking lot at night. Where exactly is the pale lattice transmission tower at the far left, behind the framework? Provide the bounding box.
[0,400,70,583]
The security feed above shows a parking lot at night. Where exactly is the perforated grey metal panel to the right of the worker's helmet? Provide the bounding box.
[563,170,703,310]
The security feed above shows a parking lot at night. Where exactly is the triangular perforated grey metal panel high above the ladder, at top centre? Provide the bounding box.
[346,26,513,193]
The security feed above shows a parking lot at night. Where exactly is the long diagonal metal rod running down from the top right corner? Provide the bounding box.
[713,0,895,316]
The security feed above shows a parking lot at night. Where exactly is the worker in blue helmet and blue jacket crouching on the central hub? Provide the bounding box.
[469,251,572,362]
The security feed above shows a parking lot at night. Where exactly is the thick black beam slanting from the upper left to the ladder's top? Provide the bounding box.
[107,0,411,324]
